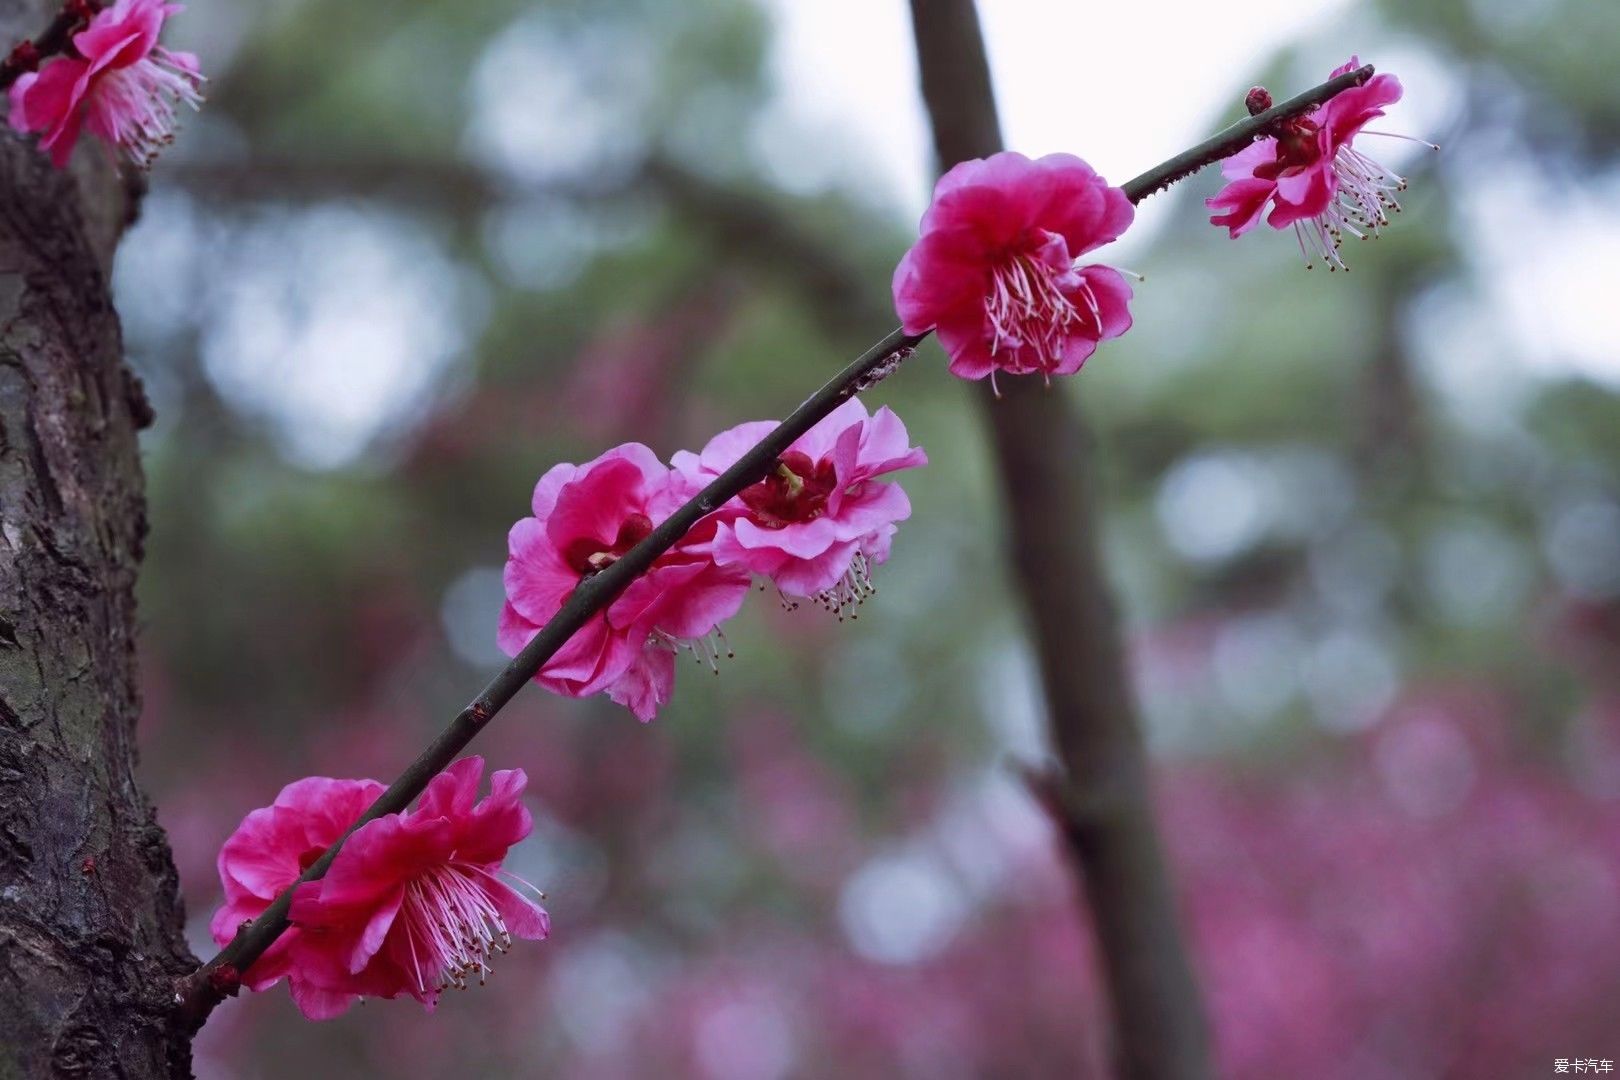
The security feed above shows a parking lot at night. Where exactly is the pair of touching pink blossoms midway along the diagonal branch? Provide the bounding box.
[499,398,928,721]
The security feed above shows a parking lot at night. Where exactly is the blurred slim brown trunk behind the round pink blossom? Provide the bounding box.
[910,0,1210,1080]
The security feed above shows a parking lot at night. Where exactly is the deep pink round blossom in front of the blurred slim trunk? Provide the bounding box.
[894,152,1136,384]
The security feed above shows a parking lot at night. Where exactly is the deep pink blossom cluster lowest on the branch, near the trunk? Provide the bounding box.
[211,758,551,1020]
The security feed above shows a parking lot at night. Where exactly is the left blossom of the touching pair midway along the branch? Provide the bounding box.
[499,442,748,721]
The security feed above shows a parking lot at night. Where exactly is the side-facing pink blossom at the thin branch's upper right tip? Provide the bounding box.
[1205,57,1425,269]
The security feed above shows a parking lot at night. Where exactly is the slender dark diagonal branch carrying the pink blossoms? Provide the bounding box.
[173,65,1372,1031]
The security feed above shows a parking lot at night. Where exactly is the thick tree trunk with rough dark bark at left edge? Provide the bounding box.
[0,0,196,1080]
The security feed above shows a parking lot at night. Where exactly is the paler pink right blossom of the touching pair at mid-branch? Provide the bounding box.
[672,398,928,614]
